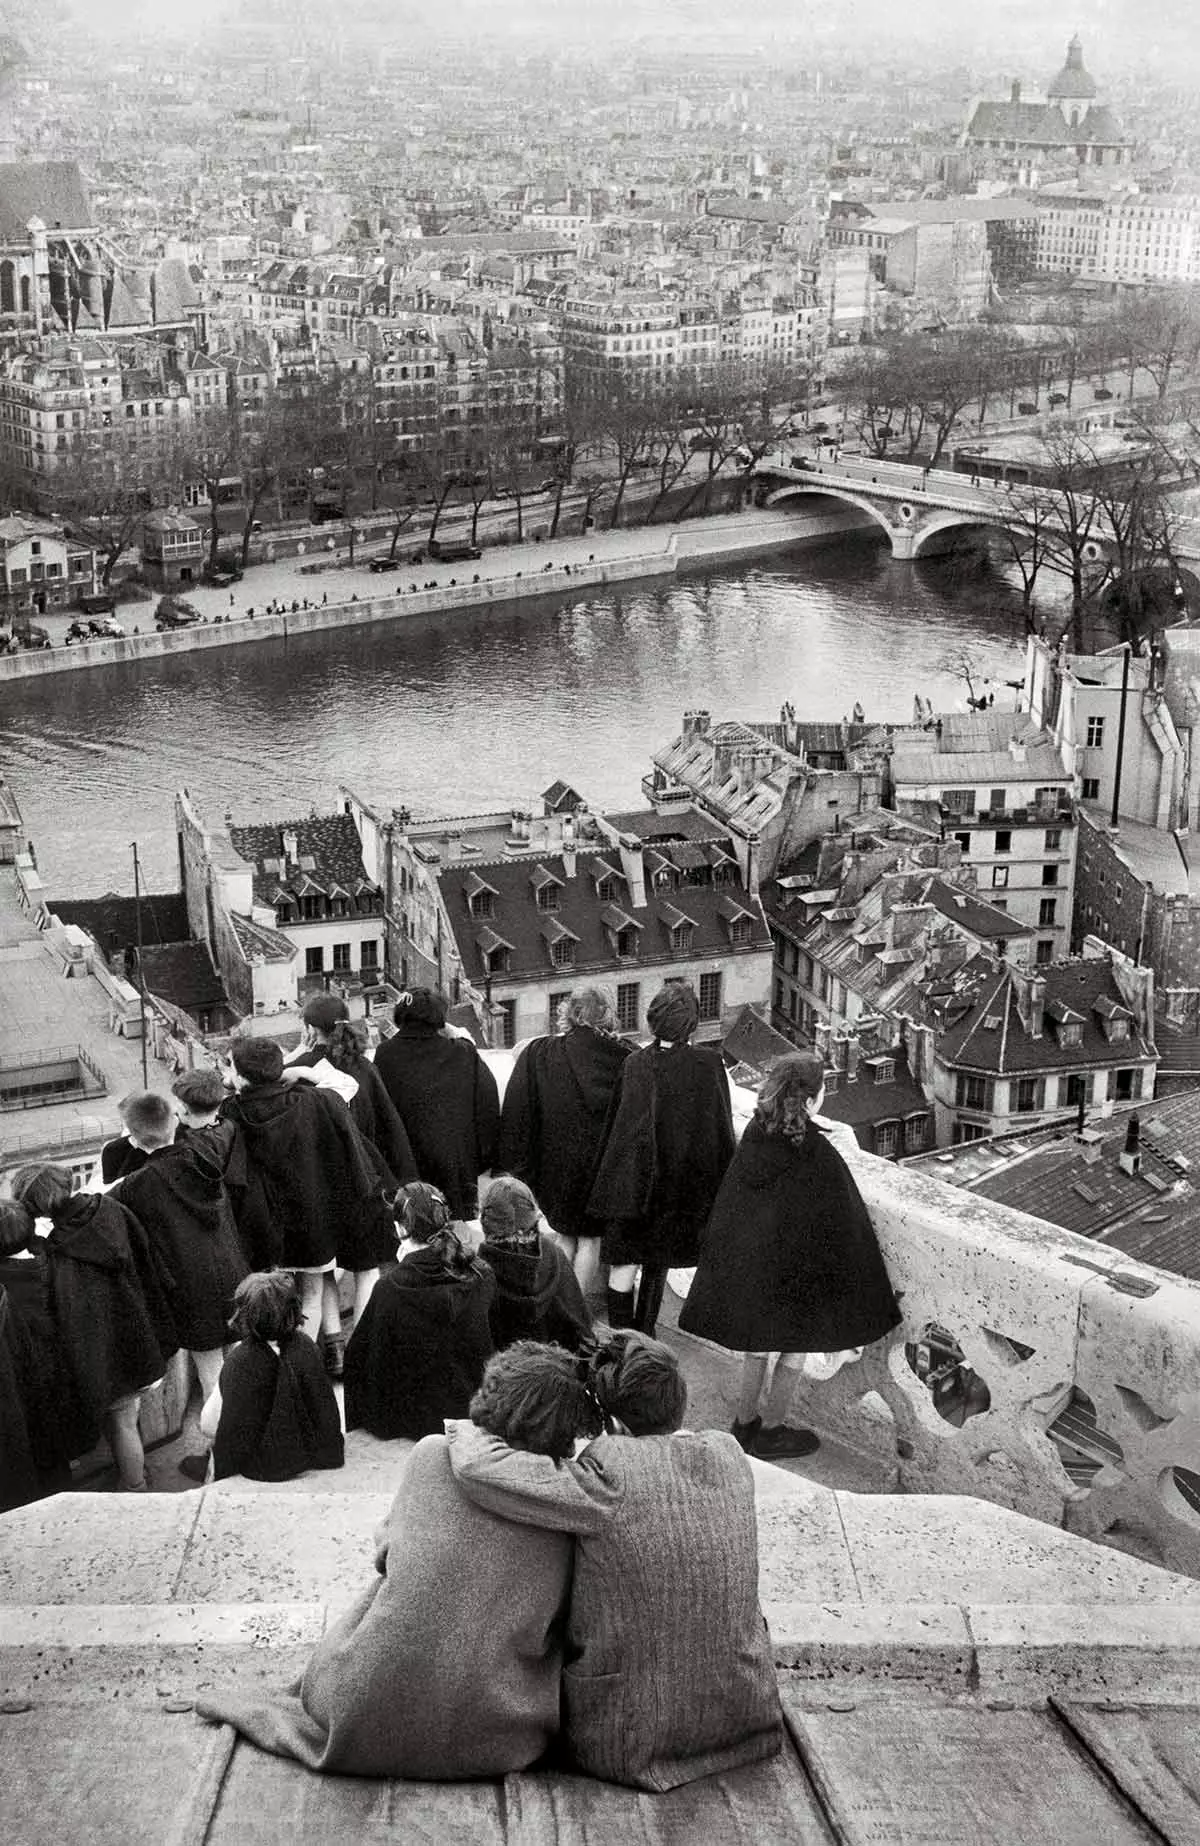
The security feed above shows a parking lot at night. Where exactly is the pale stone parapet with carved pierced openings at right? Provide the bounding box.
[779,1154,1200,1576]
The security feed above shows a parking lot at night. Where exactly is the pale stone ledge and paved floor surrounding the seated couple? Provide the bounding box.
[0,1464,1200,1846]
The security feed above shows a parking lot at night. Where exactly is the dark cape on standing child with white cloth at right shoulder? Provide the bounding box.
[225,1082,380,1268]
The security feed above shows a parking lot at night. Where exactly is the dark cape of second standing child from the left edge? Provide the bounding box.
[44,1193,177,1416]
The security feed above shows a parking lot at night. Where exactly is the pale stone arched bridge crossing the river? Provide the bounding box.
[753,456,1200,563]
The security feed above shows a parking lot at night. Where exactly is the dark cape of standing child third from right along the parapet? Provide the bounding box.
[500,1026,633,1237]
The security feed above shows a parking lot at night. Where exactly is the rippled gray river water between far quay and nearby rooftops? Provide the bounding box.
[0,539,1023,897]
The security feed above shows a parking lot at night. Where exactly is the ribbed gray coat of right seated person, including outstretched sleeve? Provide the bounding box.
[447,1421,783,1791]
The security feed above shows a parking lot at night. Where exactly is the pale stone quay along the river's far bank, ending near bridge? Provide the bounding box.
[0,511,873,683]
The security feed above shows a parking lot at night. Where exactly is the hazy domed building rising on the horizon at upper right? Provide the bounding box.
[962,33,1134,185]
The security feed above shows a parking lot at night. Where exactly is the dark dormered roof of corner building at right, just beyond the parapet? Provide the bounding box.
[938,958,1152,1076]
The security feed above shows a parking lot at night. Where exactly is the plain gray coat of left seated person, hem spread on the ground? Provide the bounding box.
[198,1436,572,1781]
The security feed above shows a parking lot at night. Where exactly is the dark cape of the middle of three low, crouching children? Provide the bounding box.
[345,1250,495,1440]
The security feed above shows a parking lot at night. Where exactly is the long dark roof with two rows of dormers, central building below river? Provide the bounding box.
[438,849,770,980]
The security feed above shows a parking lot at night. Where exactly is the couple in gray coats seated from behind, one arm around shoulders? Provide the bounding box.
[198,1333,783,1791]
